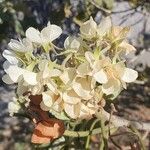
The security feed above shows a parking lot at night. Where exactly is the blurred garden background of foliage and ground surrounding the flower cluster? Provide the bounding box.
[0,0,150,150]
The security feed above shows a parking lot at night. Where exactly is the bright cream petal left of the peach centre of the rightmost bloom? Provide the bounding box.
[94,69,108,84]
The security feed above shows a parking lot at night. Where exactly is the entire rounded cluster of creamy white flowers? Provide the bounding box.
[2,17,138,143]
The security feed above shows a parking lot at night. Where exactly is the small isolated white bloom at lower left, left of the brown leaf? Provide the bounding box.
[8,97,21,116]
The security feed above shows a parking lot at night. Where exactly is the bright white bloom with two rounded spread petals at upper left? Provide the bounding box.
[26,23,62,46]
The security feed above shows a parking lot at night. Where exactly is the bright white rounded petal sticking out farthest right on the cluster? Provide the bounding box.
[121,68,138,83]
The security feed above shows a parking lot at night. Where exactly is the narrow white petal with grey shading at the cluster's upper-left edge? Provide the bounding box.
[3,50,18,64]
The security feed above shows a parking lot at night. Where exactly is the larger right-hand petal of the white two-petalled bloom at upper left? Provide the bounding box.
[41,25,62,42]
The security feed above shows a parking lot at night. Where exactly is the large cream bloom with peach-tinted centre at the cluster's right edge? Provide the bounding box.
[86,52,138,95]
